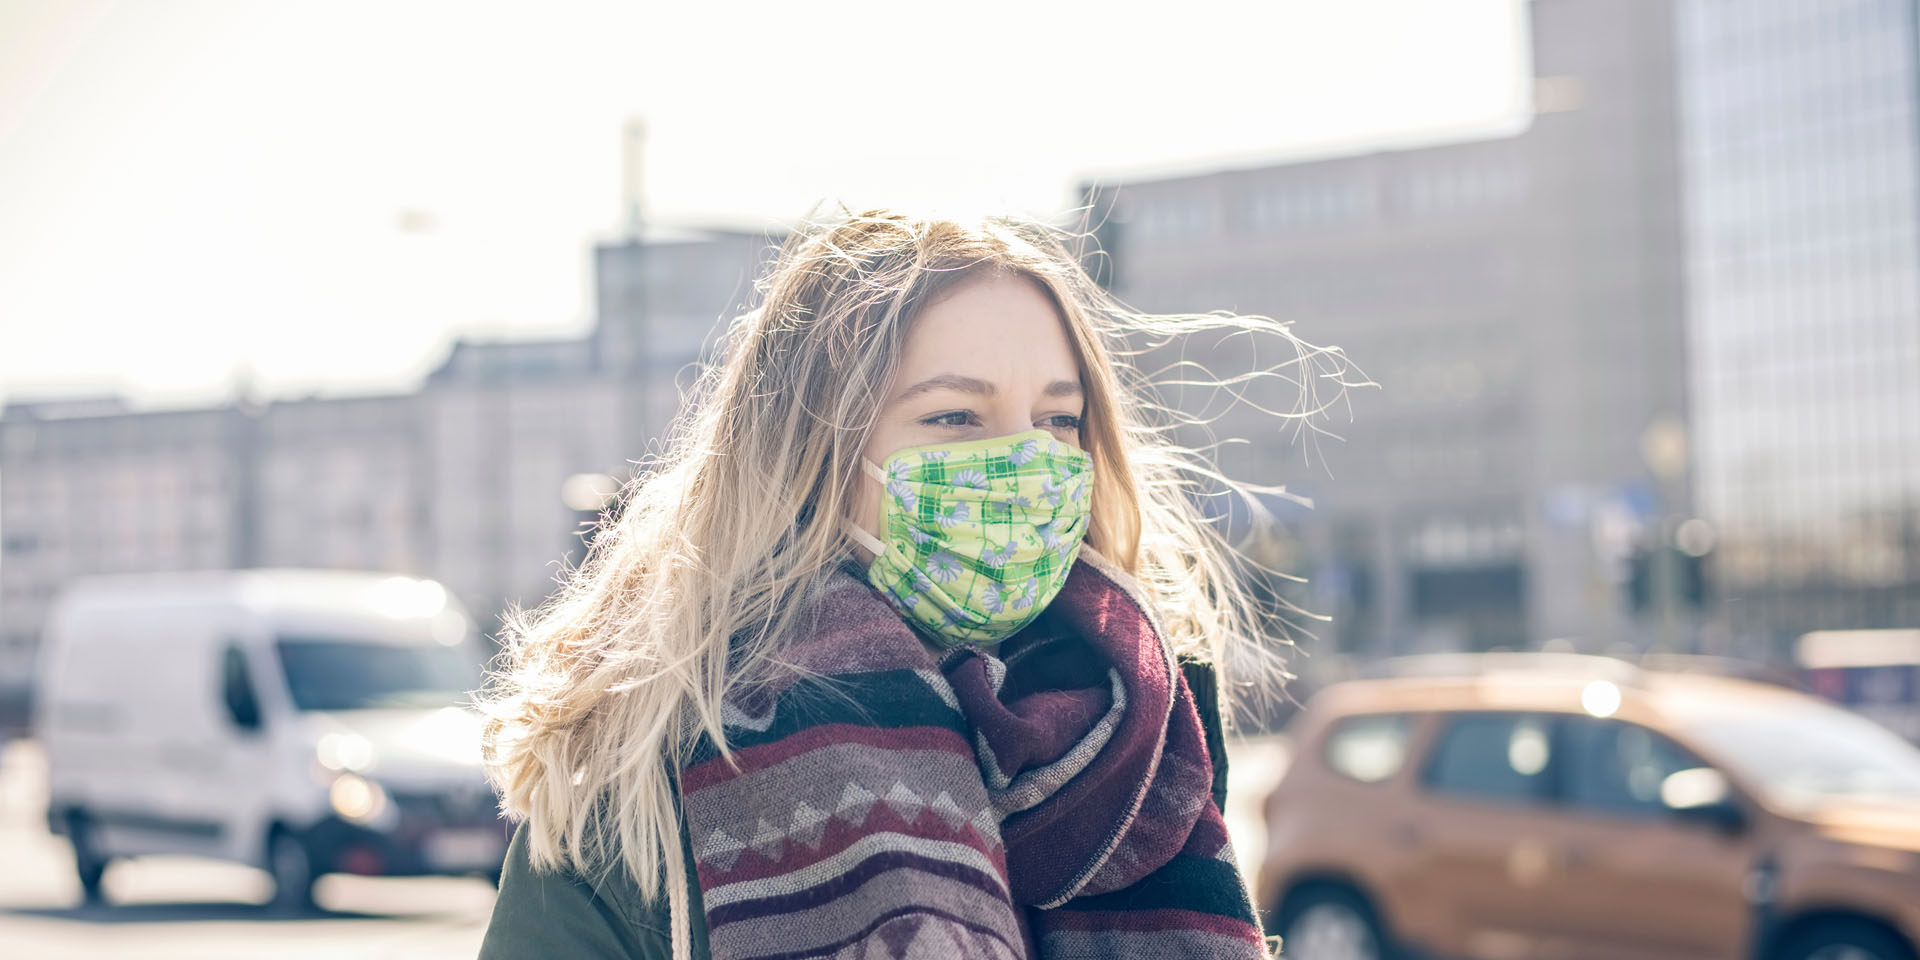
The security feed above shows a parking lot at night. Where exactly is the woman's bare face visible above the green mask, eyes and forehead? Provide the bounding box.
[852,273,1087,561]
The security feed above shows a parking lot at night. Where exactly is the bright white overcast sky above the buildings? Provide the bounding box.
[0,0,1526,405]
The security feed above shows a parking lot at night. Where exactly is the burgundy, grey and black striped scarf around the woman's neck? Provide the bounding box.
[680,551,1267,960]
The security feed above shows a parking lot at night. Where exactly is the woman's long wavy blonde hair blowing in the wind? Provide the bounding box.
[480,209,1346,958]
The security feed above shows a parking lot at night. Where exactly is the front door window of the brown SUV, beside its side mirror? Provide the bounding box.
[1561,716,1707,816]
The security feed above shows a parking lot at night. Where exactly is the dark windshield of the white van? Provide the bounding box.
[275,637,480,710]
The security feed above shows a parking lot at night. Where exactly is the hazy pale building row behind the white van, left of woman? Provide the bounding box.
[0,228,778,701]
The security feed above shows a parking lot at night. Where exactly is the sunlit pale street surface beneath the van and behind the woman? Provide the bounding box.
[0,739,1284,960]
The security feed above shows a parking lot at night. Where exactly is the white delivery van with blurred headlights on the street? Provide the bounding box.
[33,570,509,910]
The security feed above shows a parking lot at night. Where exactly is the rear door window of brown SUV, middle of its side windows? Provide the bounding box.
[1423,712,1553,803]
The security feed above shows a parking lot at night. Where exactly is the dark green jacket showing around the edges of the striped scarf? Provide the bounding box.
[480,660,1227,960]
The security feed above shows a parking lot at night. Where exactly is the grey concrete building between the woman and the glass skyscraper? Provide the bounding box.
[1087,0,1688,668]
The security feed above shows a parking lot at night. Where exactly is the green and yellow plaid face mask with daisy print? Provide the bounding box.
[847,430,1092,645]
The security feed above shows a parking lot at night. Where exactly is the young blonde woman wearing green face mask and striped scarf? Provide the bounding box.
[470,211,1336,960]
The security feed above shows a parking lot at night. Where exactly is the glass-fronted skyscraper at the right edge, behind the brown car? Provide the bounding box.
[1676,0,1920,653]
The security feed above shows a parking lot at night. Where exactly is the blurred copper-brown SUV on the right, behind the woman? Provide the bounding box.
[1256,655,1920,960]
